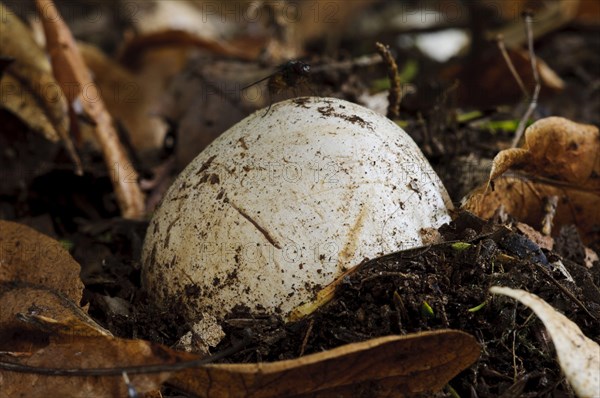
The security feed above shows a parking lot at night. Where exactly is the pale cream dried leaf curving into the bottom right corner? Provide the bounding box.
[490,286,600,398]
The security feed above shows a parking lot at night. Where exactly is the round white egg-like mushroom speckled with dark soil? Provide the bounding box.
[142,97,452,322]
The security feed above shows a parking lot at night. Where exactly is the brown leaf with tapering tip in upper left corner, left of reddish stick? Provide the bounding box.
[0,3,82,174]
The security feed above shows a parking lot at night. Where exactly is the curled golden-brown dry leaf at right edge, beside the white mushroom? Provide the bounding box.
[463,117,600,243]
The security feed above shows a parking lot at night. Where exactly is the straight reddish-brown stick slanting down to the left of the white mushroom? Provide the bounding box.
[36,0,144,219]
